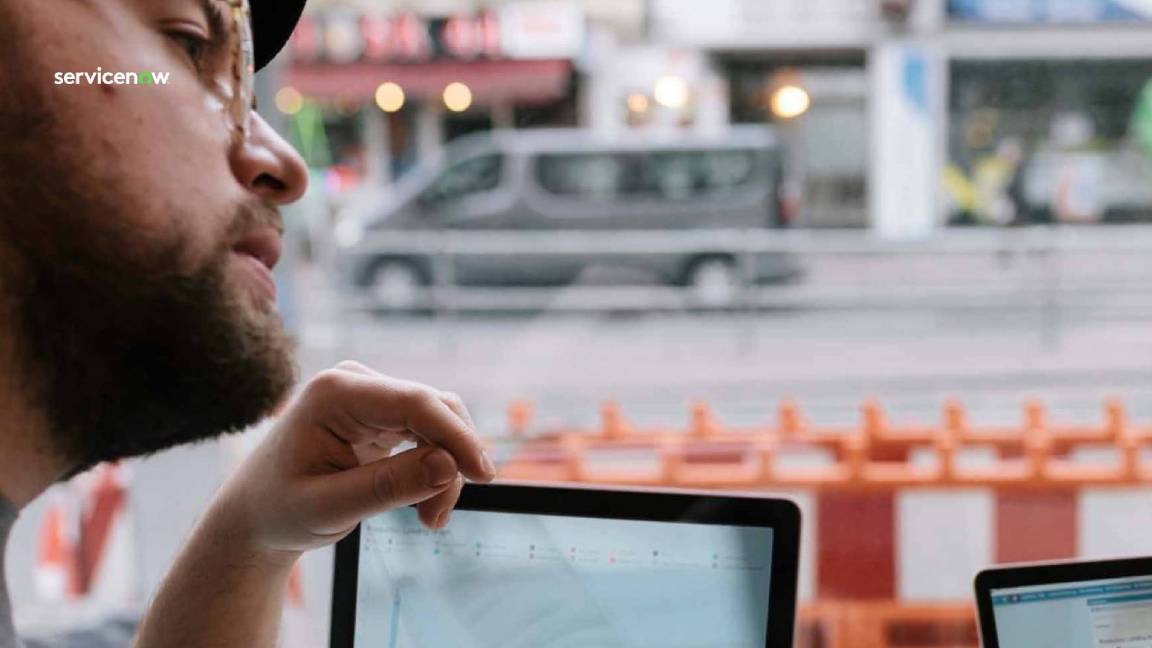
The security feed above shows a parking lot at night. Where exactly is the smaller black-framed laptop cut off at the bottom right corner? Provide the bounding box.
[976,558,1152,648]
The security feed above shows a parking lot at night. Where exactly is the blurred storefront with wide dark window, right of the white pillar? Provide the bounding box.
[943,0,1152,225]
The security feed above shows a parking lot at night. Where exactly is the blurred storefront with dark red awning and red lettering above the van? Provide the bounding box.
[276,2,585,181]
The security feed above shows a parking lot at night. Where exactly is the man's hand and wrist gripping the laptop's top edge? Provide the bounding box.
[212,362,495,559]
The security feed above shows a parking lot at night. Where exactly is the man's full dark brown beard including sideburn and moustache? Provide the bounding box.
[0,109,296,474]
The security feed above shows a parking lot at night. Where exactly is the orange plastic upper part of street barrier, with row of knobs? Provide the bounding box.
[499,400,1152,489]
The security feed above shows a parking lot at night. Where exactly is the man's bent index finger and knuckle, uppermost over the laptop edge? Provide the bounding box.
[305,363,495,481]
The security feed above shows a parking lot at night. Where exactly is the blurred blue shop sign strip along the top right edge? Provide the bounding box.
[948,0,1152,24]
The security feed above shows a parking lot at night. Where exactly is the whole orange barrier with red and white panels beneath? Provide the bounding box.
[488,401,1152,648]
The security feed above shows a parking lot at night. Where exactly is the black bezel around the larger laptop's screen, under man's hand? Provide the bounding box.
[329,483,799,648]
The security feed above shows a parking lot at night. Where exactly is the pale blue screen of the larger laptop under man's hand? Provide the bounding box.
[355,508,773,648]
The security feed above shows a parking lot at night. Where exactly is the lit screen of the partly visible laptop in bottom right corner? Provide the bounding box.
[991,577,1152,648]
